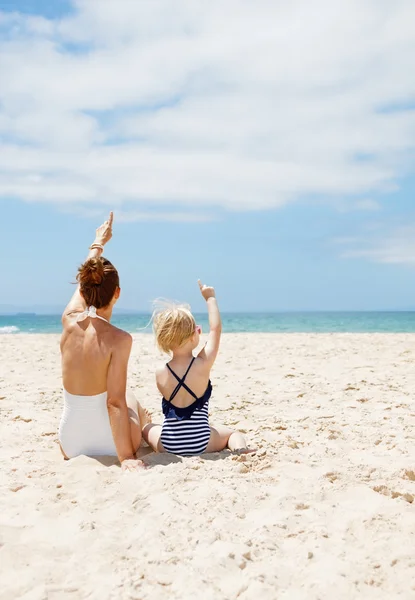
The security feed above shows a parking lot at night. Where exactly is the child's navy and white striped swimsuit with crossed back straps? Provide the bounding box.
[160,358,212,456]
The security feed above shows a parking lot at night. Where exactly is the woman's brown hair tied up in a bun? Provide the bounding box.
[76,256,120,308]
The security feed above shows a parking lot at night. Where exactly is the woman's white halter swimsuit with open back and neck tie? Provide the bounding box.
[59,306,117,458]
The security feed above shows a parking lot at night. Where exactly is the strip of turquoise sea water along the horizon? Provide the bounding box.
[0,312,415,334]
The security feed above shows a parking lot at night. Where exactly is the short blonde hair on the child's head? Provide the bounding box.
[153,300,196,354]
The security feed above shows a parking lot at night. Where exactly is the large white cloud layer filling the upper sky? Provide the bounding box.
[0,0,415,219]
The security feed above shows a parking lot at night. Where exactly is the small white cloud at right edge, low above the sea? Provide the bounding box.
[336,225,415,265]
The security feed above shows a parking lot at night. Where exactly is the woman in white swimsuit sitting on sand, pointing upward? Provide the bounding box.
[59,213,148,471]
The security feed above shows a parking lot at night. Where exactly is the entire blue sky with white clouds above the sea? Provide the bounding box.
[0,0,415,311]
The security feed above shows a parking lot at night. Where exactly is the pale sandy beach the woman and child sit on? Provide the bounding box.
[0,334,415,600]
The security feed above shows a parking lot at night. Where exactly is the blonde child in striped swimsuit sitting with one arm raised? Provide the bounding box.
[143,280,254,456]
